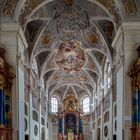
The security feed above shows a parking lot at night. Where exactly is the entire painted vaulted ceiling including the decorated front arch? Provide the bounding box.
[0,0,140,98]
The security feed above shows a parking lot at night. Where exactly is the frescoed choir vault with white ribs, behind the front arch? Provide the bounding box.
[29,0,110,96]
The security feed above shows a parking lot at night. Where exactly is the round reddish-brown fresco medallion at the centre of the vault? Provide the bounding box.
[55,41,86,72]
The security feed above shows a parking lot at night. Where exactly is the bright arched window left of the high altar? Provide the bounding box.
[51,97,58,113]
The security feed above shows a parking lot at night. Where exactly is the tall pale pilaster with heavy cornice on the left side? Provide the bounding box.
[0,23,28,140]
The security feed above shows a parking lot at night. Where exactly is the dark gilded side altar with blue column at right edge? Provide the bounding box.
[129,46,140,139]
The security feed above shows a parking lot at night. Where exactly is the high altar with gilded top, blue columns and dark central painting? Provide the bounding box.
[58,95,84,140]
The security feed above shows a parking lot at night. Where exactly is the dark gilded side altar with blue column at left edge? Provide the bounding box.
[0,47,15,133]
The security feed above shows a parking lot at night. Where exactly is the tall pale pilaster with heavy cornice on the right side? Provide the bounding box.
[112,22,140,140]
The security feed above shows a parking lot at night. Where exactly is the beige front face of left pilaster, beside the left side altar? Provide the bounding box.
[0,24,18,140]
